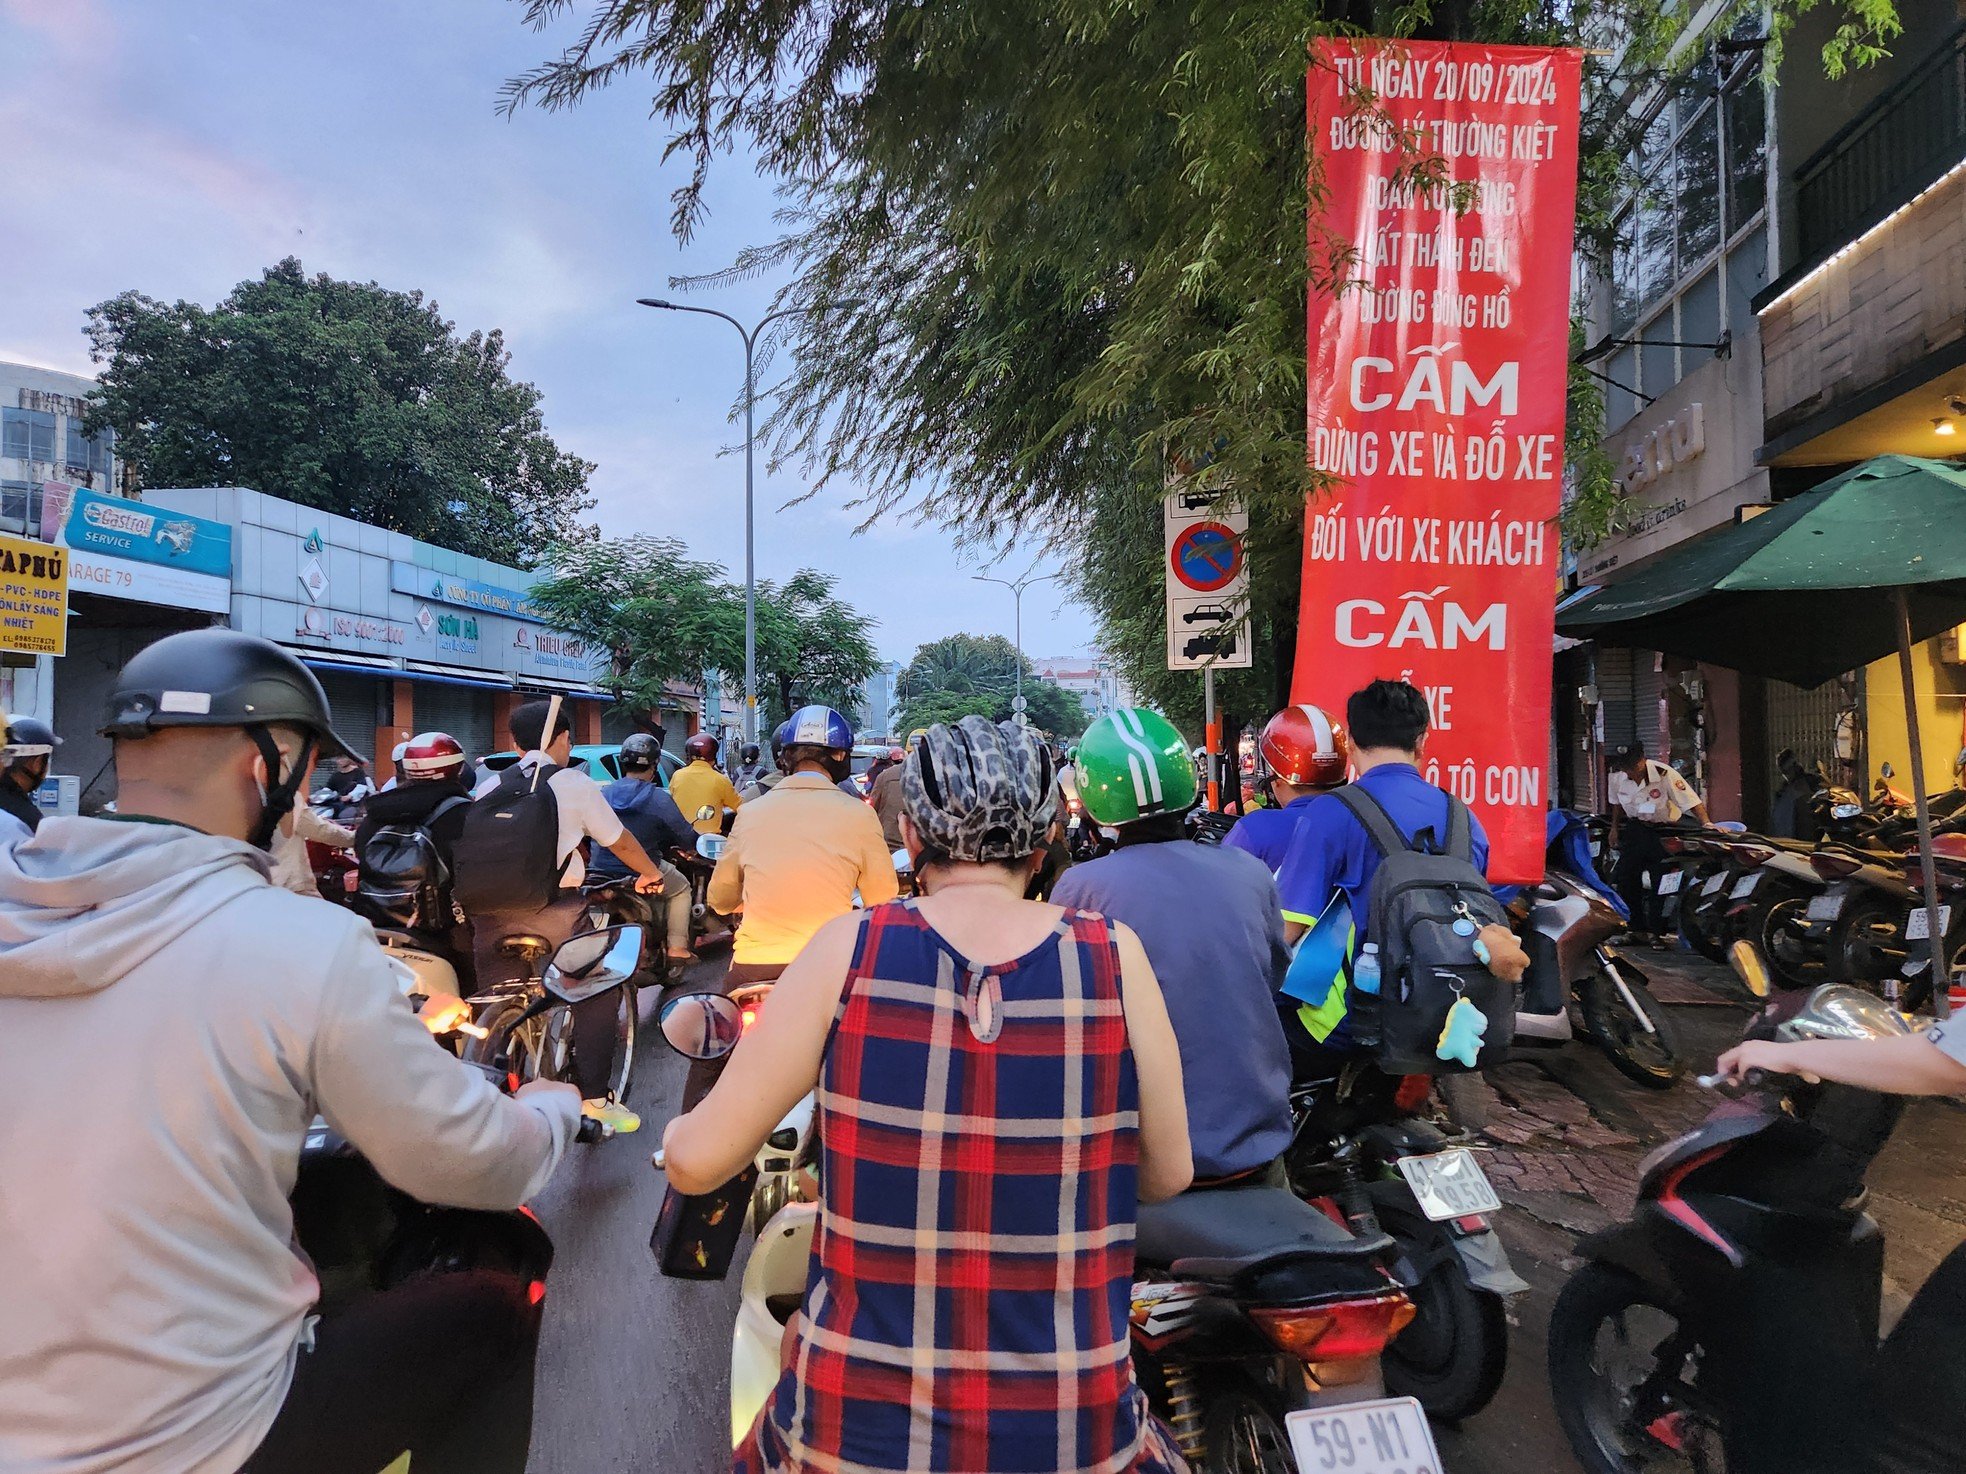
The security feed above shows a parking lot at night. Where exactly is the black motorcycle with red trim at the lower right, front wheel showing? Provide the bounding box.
[1549,943,1934,1474]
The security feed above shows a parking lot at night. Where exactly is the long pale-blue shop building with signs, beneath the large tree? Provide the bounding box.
[147,487,609,776]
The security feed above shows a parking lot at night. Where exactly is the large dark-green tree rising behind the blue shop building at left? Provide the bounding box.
[87,257,594,564]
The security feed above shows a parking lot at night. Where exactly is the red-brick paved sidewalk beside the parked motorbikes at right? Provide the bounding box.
[1482,951,1966,1317]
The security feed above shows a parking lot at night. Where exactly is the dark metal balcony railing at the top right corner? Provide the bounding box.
[1795,24,1966,263]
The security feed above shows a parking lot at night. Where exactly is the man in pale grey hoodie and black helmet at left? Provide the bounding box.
[0,629,580,1474]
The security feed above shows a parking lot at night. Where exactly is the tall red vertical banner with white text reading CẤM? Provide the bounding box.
[1292,39,1583,880]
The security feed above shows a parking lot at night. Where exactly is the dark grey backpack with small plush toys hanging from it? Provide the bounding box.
[1337,784,1516,1075]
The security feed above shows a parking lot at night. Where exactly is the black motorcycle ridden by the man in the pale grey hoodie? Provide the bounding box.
[291,937,641,1315]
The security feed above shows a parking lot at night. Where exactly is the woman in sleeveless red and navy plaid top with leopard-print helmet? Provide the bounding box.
[663,717,1193,1474]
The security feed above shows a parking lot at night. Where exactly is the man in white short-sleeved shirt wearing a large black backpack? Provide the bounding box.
[458,702,663,1132]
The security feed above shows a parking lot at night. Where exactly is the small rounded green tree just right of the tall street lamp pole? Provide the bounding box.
[751,568,881,725]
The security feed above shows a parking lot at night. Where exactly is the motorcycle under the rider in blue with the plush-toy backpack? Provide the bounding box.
[1284,1059,1528,1421]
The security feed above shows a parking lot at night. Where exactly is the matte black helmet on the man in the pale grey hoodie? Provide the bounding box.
[102,629,354,849]
